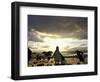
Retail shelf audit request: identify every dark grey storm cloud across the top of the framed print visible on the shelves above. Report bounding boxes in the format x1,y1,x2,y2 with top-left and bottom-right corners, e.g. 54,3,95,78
28,15,87,39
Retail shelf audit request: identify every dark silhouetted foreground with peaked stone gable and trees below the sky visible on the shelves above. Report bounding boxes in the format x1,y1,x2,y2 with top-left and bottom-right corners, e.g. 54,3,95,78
28,46,87,67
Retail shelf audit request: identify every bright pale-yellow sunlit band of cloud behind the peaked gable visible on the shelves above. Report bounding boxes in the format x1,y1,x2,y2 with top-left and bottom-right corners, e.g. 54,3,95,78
28,30,87,51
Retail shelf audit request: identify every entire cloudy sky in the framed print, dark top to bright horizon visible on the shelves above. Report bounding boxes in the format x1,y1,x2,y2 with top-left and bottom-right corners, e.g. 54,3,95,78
28,15,88,52
